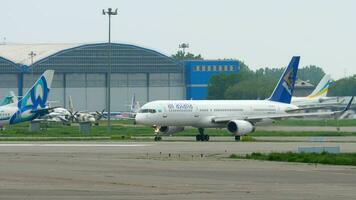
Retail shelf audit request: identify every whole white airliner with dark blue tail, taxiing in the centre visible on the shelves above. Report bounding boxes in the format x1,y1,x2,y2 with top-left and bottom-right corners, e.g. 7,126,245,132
135,56,353,141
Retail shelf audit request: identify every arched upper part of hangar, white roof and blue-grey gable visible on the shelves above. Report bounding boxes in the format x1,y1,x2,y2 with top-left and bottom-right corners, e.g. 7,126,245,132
0,43,183,73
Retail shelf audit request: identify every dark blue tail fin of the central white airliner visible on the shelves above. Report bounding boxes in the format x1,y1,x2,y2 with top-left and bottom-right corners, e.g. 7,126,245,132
269,56,300,104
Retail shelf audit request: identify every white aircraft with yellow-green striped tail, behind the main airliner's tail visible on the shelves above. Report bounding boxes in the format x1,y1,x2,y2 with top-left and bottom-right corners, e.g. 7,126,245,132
291,74,338,108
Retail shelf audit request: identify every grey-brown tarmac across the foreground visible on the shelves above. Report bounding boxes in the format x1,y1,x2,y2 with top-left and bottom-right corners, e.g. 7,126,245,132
0,141,356,200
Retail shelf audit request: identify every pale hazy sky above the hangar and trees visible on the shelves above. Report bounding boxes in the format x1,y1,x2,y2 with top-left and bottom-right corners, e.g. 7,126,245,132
0,0,356,79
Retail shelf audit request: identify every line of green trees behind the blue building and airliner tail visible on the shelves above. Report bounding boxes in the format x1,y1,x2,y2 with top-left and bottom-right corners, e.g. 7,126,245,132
172,50,356,99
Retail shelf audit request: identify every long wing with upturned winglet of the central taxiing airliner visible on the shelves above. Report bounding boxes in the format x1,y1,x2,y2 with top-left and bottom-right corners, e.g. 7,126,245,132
212,97,354,123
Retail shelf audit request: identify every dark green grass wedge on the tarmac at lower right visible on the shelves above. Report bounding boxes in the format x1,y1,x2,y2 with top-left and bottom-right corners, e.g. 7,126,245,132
230,152,356,166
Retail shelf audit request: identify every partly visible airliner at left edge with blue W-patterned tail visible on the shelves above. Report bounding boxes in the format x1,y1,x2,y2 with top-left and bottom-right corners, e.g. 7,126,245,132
0,70,54,126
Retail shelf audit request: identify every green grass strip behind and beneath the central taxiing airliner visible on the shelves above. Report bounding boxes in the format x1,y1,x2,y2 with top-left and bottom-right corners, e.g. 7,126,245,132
0,120,356,141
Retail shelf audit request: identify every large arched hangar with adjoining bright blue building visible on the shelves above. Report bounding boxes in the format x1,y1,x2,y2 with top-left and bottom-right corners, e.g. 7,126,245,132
0,43,239,111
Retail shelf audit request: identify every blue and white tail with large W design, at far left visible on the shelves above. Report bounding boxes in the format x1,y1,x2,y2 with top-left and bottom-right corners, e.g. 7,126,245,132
10,70,54,124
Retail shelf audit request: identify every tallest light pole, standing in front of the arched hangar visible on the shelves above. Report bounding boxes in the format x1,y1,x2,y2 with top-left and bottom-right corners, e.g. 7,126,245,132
103,8,117,132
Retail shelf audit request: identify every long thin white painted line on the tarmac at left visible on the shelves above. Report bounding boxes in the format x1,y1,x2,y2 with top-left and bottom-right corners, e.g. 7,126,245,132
0,143,152,147
